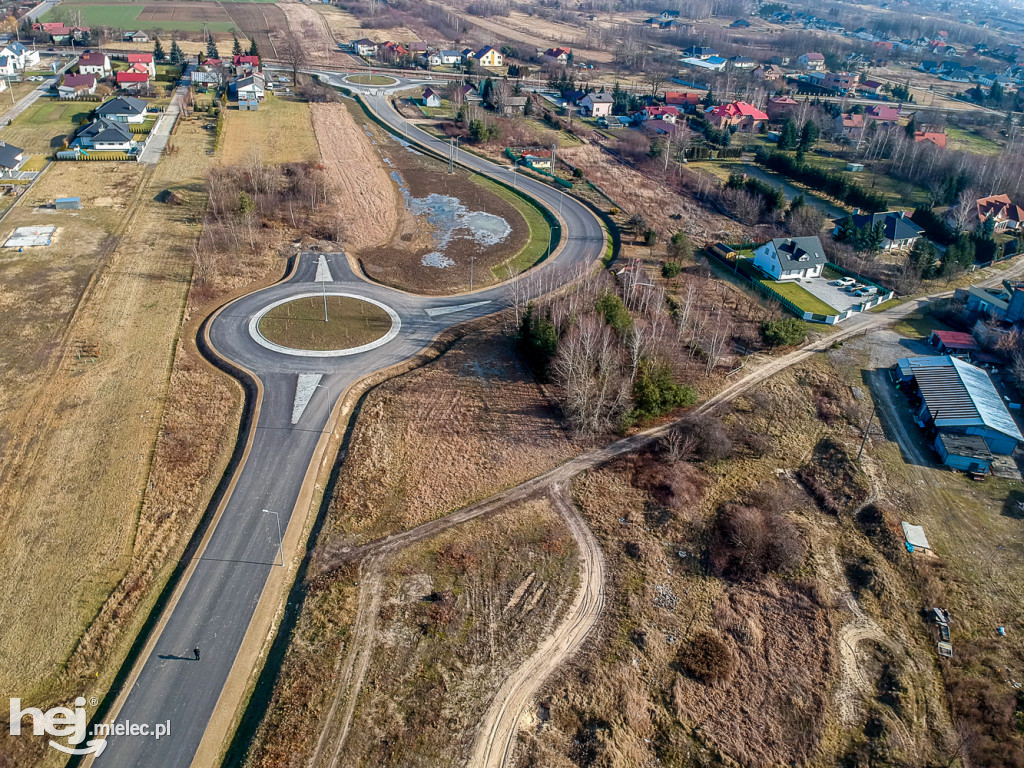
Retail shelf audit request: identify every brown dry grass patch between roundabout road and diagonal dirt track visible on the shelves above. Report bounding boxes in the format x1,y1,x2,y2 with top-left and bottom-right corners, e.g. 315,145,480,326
329,330,583,543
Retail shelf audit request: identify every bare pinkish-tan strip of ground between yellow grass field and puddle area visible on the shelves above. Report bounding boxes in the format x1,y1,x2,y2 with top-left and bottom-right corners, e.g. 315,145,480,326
309,100,398,250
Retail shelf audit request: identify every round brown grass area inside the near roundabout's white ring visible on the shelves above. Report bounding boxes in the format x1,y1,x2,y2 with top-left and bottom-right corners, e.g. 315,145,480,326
259,294,392,351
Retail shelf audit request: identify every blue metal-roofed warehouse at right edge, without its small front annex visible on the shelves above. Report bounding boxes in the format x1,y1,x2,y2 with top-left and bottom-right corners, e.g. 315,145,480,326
896,355,1024,455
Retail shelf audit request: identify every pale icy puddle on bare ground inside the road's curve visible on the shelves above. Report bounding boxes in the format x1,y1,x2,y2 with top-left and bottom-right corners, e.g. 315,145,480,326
391,171,512,269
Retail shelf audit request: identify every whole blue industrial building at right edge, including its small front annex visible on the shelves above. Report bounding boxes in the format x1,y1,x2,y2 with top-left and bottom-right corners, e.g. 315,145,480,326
893,355,1024,474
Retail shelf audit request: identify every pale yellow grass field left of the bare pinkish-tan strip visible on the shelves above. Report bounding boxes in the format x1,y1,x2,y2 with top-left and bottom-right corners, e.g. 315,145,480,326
220,94,319,165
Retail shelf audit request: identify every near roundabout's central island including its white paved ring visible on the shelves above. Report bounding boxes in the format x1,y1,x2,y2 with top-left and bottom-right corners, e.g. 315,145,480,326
249,291,401,357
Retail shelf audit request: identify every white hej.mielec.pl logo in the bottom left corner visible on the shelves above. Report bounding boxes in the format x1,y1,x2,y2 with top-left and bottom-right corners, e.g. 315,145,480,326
10,696,171,757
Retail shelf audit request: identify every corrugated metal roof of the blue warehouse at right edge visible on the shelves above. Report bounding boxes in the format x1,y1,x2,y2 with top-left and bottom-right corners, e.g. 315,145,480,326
899,355,1024,442
